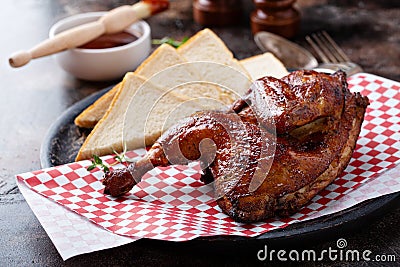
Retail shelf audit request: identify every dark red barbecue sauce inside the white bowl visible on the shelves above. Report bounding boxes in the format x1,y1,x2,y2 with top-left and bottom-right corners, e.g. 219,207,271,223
78,32,138,49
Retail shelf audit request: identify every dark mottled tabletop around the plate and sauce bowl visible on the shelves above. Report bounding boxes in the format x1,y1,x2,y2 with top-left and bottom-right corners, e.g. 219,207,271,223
0,0,400,266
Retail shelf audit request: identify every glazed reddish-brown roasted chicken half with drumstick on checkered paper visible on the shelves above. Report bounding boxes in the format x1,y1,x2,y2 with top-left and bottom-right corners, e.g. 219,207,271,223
103,71,369,222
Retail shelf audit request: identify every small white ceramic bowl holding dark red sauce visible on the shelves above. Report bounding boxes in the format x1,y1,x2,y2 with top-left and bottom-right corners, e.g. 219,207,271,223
49,12,151,81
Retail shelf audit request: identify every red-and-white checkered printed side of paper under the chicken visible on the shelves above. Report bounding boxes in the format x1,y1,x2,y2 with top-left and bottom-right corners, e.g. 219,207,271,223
17,73,400,247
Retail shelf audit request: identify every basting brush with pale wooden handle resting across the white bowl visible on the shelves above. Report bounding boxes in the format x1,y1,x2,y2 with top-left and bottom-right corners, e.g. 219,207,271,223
8,0,169,68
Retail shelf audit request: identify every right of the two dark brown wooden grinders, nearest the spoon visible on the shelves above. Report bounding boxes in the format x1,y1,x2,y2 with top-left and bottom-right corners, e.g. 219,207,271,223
250,0,300,38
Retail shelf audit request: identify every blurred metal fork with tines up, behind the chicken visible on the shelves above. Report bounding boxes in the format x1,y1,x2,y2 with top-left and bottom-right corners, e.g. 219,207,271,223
305,31,363,76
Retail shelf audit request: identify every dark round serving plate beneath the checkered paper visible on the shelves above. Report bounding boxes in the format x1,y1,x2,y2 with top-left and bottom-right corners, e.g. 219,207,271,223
40,87,400,243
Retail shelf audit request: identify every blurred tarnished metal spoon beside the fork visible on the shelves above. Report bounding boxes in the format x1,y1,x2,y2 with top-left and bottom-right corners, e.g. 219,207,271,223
254,32,318,69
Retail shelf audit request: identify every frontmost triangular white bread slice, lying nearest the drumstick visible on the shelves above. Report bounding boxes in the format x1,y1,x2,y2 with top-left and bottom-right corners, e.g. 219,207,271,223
76,73,199,161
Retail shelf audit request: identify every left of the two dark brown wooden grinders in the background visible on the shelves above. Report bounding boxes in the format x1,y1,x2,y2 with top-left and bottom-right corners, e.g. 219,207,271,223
193,0,242,26
